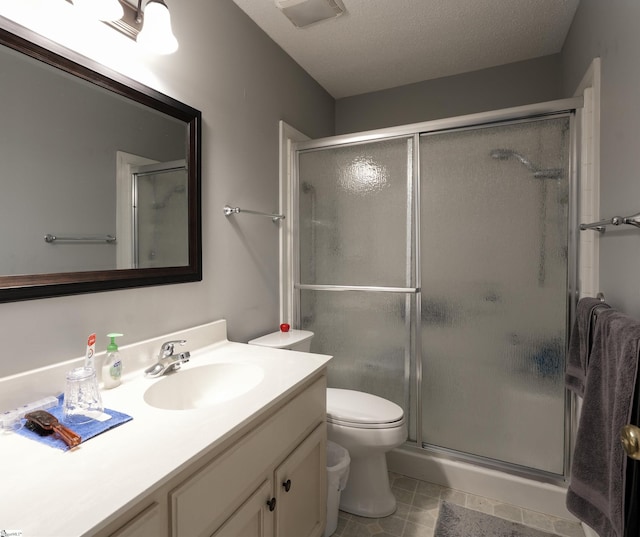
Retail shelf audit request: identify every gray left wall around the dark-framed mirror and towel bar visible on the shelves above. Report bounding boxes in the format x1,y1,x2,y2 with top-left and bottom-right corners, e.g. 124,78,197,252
0,0,334,377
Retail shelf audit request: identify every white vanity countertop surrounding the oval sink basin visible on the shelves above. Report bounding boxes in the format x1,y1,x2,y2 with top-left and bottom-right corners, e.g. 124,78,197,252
0,321,330,537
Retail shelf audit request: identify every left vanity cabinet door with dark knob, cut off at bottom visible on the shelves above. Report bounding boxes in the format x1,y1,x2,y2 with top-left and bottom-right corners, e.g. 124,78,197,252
211,481,273,537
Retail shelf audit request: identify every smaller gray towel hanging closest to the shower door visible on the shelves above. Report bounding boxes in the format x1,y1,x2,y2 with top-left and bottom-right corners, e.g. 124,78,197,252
564,297,610,397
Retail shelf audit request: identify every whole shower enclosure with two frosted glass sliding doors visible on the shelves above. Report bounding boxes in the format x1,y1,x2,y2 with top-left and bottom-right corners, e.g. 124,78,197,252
290,99,575,516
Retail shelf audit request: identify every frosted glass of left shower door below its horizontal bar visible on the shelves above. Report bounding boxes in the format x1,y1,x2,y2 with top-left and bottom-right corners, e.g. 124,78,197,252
300,290,410,412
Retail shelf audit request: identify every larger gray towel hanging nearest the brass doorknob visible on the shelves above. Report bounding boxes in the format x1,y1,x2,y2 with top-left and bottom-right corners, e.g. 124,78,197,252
567,309,640,537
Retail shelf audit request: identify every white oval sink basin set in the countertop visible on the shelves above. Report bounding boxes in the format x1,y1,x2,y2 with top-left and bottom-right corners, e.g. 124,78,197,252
144,363,264,410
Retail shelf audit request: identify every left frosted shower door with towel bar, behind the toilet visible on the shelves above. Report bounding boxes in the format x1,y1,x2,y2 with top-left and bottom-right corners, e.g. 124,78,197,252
296,136,416,411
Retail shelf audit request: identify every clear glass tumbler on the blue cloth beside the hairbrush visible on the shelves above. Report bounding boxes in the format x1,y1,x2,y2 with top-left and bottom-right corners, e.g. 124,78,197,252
62,367,104,425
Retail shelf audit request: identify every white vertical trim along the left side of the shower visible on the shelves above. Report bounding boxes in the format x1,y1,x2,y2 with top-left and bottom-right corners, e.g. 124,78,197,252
278,120,310,324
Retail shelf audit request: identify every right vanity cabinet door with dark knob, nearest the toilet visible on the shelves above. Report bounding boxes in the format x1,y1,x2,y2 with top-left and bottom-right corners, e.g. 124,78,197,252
275,423,327,537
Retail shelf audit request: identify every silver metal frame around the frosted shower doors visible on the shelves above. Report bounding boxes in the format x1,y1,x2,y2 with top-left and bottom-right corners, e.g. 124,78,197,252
290,96,583,483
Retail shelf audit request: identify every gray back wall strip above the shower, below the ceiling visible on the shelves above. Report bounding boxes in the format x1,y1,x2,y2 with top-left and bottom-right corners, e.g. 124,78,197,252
336,54,562,134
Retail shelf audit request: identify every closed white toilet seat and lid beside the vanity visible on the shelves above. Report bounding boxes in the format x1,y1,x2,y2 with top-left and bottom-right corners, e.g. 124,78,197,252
327,388,405,429
